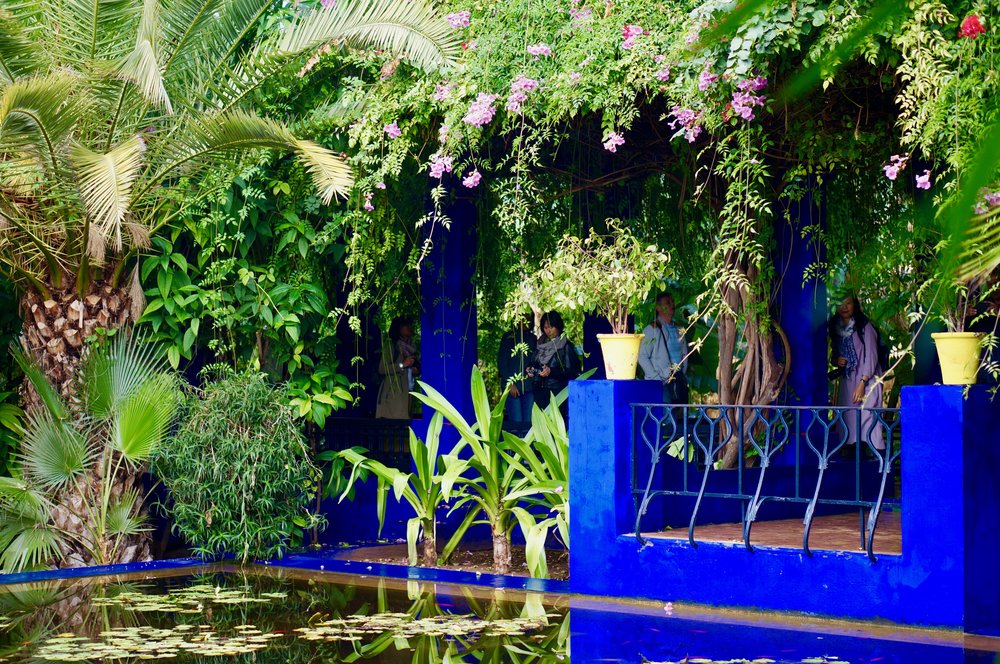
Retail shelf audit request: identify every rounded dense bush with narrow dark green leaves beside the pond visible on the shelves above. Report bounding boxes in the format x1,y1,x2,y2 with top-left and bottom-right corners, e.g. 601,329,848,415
155,368,321,561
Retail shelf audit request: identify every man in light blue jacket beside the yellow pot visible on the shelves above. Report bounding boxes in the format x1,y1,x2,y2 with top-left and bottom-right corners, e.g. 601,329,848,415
639,293,689,404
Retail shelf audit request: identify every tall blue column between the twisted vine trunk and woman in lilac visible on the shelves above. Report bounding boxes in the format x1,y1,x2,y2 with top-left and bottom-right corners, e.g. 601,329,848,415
774,178,829,406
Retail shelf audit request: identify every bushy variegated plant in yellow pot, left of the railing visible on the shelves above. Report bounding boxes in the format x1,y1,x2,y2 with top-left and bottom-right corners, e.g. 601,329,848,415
513,219,670,380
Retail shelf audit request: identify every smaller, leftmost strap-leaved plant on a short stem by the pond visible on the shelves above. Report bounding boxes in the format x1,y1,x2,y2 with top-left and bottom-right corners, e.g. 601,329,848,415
324,413,469,566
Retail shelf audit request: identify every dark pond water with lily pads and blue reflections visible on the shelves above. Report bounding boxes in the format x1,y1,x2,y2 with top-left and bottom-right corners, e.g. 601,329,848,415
0,567,1000,664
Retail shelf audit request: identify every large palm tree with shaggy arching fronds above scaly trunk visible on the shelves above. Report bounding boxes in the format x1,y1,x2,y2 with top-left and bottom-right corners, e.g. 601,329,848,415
0,0,458,395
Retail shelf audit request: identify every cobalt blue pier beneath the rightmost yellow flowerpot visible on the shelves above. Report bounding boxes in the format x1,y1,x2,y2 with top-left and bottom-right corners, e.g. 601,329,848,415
901,385,1000,636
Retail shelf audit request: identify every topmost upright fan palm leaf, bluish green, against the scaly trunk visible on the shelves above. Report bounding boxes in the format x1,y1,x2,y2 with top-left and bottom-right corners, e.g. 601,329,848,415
79,334,166,422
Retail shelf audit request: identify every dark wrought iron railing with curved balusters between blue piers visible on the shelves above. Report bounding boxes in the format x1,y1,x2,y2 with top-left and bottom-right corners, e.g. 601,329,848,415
632,404,900,562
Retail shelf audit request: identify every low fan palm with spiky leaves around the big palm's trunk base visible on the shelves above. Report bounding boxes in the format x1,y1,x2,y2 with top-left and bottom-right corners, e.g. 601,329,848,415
0,334,180,572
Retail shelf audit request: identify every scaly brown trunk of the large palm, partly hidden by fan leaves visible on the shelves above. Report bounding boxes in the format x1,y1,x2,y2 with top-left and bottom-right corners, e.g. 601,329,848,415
21,282,150,567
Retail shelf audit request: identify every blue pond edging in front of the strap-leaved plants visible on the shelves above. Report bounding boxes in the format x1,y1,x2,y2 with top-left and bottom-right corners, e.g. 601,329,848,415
259,549,570,593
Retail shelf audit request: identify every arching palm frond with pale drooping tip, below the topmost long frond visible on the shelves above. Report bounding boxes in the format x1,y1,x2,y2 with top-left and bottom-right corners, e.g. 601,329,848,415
143,111,353,203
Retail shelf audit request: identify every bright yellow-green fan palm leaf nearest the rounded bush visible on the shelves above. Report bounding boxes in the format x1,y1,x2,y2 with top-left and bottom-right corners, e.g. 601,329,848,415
111,373,180,463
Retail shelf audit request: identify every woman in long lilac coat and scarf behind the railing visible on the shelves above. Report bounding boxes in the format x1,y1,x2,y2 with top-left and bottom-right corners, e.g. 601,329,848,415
828,295,885,450
